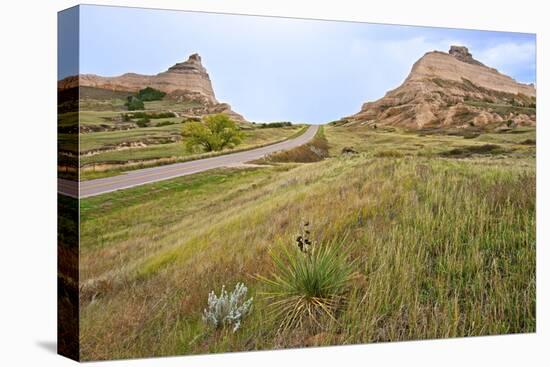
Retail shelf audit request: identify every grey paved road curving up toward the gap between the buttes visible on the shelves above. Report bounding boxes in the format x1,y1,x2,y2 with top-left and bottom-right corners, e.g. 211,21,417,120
57,125,319,198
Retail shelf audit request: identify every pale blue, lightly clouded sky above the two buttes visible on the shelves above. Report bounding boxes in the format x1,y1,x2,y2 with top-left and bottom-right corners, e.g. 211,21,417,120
58,5,536,123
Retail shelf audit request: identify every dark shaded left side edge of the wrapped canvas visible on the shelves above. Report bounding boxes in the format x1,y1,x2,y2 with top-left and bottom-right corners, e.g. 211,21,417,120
57,7,80,360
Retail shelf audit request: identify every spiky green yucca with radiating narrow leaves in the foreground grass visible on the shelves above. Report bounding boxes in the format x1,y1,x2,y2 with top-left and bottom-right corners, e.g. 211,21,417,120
259,241,353,331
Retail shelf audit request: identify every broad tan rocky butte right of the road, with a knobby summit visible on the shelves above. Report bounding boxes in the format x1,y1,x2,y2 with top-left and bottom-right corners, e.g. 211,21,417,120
348,46,536,129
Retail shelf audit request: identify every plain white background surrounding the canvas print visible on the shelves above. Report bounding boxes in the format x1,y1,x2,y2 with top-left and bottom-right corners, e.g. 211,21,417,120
0,0,550,367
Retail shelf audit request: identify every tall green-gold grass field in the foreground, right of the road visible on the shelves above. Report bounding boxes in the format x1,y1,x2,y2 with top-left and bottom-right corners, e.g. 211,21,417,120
80,127,535,360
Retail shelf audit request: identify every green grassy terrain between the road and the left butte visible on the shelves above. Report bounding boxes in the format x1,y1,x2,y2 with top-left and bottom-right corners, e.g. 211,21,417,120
66,92,305,180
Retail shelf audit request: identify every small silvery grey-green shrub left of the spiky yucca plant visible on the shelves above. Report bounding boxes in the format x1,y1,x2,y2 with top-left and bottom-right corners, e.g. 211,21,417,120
202,283,252,332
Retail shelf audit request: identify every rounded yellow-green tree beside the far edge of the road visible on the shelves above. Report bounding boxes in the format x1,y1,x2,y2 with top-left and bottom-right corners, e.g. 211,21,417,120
183,113,243,152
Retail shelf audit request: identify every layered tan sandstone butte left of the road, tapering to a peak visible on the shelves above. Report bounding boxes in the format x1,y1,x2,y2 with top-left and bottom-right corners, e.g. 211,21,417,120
58,53,244,121
